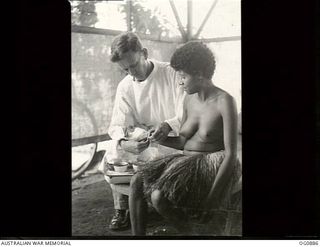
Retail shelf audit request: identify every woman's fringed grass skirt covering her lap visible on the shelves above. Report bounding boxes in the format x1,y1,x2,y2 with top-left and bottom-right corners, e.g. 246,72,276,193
139,151,241,210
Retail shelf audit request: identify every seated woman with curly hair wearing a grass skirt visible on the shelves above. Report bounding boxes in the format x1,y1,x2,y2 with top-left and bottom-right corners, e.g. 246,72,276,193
129,41,239,235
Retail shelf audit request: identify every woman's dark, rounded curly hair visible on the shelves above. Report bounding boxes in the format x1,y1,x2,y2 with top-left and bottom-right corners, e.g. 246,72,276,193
170,41,216,80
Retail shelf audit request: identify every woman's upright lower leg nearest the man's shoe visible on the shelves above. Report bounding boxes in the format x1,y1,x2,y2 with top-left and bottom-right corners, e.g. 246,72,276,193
129,173,148,236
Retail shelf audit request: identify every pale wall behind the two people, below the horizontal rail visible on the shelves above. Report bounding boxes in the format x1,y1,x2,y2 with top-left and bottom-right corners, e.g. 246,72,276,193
71,33,241,139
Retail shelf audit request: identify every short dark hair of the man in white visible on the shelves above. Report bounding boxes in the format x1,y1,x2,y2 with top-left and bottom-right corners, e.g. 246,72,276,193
110,32,143,62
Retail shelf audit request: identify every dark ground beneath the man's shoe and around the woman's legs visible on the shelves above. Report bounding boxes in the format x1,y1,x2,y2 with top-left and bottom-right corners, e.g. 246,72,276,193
72,173,242,236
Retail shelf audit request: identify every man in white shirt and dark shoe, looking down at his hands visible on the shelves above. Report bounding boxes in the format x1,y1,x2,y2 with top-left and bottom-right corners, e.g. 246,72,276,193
108,32,185,230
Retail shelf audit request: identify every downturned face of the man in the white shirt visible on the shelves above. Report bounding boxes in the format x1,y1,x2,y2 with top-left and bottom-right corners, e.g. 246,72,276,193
117,51,147,81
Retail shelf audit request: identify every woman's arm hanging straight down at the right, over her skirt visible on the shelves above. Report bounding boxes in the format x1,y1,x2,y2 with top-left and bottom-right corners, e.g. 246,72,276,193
207,95,238,207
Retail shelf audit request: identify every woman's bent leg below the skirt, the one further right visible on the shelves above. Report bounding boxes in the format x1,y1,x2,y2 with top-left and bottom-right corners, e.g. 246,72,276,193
151,190,190,234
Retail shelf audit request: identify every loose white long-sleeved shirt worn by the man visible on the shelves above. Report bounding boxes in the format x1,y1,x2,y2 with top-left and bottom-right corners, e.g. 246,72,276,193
108,60,185,140
